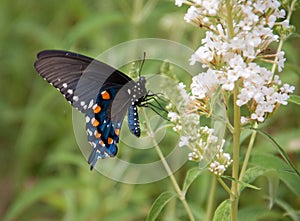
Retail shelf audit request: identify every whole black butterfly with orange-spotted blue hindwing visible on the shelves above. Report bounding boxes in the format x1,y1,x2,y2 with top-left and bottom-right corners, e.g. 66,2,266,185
34,50,162,170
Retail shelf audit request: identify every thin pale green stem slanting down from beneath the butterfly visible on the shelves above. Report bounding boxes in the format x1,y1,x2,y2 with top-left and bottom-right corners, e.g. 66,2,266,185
142,109,195,221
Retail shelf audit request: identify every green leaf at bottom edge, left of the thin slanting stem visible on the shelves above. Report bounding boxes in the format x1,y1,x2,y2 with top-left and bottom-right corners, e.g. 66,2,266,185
146,191,176,221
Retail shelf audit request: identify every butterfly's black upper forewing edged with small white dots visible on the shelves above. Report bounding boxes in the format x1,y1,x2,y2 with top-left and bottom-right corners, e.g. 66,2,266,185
34,50,131,113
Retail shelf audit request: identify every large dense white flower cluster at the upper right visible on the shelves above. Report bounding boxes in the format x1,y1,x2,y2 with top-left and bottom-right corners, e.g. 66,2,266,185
175,0,295,123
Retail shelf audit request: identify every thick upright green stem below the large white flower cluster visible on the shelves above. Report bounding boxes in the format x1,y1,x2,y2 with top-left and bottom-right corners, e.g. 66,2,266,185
230,81,241,221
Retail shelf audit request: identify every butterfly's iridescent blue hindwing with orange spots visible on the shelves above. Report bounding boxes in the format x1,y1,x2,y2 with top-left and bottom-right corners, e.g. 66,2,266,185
86,76,132,169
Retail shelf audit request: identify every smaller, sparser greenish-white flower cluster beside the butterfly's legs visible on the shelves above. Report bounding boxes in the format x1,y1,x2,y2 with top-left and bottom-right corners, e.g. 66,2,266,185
164,80,232,175
